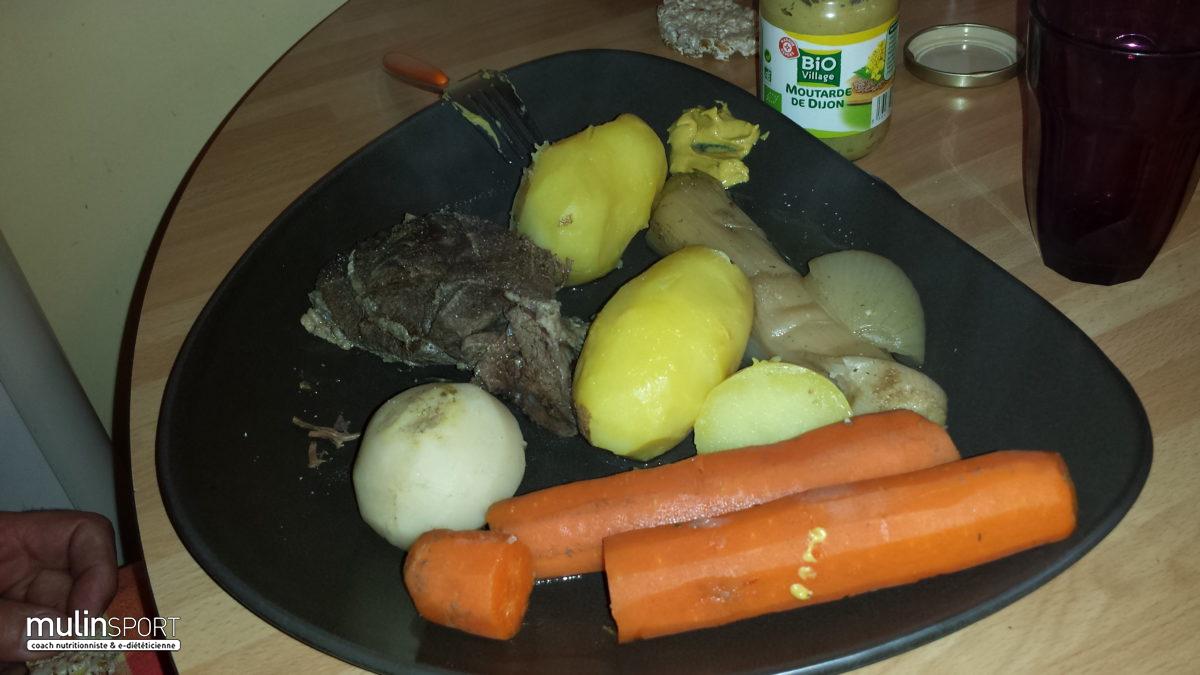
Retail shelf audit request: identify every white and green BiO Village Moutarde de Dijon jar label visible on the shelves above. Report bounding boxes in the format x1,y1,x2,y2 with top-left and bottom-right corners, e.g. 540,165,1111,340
761,17,900,138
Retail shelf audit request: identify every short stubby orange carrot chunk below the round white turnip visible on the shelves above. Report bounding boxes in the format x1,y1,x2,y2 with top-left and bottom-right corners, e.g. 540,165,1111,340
404,530,534,640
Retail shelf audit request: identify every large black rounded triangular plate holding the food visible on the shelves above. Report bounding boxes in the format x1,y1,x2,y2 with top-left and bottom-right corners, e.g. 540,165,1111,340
157,50,1151,674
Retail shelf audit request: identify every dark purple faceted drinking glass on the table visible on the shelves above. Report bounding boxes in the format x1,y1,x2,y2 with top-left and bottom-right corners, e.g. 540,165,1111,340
1024,0,1200,285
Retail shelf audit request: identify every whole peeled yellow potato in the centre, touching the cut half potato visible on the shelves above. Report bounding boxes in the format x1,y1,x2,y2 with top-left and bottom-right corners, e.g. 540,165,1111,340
572,246,754,460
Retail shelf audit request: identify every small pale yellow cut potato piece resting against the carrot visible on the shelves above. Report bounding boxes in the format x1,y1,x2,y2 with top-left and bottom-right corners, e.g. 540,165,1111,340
696,360,851,453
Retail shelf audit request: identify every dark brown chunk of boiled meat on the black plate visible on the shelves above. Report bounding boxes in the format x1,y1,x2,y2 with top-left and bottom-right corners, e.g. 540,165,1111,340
300,213,587,436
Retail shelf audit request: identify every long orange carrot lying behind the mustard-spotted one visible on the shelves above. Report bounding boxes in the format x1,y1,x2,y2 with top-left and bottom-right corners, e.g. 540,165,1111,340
487,411,959,579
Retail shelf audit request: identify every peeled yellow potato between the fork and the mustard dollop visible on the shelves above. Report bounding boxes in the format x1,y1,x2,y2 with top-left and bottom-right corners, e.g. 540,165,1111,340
512,114,667,286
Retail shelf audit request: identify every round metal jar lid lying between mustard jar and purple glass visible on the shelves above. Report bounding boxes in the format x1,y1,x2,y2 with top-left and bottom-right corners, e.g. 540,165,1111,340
904,24,1025,88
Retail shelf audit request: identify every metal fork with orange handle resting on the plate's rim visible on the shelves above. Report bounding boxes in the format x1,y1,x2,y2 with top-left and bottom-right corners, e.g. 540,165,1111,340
383,52,544,166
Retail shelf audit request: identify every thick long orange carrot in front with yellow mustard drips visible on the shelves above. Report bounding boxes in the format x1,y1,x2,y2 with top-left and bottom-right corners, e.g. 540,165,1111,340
604,450,1075,643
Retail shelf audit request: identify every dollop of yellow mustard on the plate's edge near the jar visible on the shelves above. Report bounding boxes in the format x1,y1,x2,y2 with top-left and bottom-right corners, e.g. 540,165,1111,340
667,101,758,187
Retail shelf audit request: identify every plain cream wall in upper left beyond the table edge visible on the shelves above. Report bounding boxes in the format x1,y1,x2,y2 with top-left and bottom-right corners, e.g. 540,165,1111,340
0,0,343,432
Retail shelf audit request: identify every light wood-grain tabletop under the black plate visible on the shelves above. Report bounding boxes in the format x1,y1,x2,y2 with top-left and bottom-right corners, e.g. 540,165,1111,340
130,0,1200,673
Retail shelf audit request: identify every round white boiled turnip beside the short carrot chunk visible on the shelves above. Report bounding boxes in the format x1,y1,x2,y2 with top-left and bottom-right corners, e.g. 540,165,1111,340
353,383,524,549
